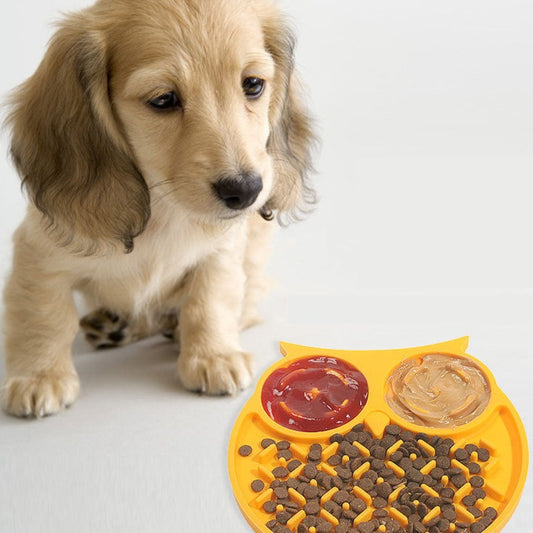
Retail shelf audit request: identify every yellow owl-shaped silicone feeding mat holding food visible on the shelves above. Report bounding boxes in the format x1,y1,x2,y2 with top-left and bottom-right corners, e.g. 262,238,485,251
228,337,528,533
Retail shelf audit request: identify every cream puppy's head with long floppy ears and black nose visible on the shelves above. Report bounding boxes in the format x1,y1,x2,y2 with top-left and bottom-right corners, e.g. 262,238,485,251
10,0,312,250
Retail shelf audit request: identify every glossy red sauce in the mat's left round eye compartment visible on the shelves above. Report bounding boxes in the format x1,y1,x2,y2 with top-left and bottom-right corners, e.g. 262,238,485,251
261,356,368,431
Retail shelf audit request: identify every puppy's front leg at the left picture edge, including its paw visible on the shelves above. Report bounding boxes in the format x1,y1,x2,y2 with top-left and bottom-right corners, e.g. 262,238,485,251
2,237,79,417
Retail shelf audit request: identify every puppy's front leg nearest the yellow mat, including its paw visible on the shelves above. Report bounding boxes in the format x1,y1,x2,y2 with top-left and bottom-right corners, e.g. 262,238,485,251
178,235,253,394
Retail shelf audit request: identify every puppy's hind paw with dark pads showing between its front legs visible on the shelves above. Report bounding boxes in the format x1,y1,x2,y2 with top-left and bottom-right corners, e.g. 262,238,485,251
80,309,133,348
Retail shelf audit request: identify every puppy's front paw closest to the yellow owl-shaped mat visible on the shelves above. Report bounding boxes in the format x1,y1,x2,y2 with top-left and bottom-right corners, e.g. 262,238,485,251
178,351,253,395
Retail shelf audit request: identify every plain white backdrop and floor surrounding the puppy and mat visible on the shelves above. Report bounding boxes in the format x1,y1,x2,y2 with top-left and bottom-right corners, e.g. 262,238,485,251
0,0,533,533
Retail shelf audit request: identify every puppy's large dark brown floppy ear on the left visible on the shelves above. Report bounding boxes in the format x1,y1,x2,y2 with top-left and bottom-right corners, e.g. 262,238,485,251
8,15,150,253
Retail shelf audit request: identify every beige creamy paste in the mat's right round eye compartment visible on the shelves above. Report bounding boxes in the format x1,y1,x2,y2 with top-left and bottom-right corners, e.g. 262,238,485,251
387,354,490,428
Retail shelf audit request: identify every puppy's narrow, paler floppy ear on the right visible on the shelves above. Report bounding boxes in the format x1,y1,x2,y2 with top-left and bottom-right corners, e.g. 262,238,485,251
263,12,316,217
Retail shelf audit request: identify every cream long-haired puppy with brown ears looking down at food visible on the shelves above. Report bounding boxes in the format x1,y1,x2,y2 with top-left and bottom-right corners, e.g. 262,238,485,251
2,0,314,417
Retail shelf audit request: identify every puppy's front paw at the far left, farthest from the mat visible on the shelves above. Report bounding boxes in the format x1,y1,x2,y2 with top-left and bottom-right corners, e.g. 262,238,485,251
2,373,80,418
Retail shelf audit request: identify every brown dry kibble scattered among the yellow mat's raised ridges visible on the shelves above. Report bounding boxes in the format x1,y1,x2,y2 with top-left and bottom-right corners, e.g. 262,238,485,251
241,424,498,533
